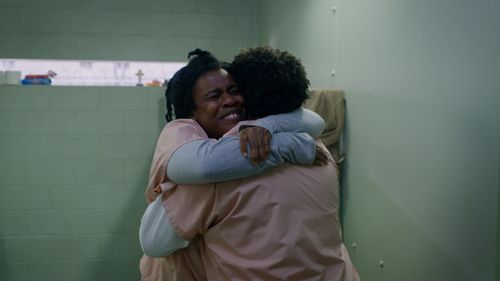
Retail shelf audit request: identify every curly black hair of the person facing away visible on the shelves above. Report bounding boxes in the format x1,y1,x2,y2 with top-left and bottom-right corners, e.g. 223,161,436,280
229,47,309,119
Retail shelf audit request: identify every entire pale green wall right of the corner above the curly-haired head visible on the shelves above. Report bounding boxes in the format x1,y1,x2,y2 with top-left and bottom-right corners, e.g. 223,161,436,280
259,0,500,281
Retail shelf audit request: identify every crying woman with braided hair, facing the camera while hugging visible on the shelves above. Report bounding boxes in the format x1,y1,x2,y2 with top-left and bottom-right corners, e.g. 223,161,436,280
140,50,326,280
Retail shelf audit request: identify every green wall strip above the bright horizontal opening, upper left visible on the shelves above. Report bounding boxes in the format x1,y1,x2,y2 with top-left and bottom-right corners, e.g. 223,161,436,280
0,0,257,61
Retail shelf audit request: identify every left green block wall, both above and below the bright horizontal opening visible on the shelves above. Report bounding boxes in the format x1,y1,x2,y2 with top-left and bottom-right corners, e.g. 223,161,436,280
0,0,258,281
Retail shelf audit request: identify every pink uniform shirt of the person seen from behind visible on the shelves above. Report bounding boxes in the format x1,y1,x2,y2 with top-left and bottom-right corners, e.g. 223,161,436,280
162,122,359,281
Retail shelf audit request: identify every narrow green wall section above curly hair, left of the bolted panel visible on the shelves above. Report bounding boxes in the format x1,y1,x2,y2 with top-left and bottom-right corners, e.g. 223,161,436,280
258,0,338,87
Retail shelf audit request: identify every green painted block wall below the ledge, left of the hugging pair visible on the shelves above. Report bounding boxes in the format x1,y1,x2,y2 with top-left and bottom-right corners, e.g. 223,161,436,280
0,86,164,281
